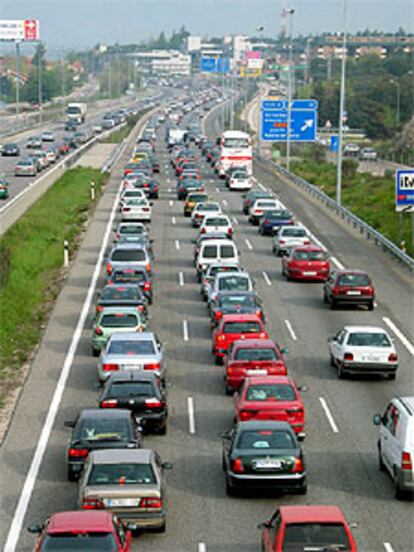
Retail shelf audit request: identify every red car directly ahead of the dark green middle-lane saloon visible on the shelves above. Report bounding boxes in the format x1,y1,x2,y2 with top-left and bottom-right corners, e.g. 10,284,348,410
233,376,305,438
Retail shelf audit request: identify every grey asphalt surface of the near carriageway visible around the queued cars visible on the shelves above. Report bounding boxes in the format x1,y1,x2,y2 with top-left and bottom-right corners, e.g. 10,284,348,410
0,92,414,552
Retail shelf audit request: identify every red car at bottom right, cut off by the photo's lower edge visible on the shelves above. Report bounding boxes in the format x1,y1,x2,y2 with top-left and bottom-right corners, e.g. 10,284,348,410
258,506,357,552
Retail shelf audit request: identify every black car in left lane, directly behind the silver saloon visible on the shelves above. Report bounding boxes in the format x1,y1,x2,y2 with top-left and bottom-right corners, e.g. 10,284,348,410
99,370,168,435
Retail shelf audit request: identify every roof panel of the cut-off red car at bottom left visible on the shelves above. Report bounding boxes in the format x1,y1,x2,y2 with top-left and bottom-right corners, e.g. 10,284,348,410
47,510,113,534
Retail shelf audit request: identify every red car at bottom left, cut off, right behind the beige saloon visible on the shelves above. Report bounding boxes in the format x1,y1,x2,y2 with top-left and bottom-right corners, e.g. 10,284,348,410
28,510,132,552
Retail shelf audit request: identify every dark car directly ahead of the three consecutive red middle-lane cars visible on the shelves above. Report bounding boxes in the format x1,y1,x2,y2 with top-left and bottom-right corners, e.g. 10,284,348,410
210,291,266,326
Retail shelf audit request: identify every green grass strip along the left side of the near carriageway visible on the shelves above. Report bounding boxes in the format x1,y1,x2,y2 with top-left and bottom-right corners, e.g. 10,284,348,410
0,168,108,407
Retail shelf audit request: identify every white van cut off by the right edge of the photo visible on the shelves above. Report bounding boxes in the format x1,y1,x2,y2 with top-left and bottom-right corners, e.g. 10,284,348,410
374,397,414,499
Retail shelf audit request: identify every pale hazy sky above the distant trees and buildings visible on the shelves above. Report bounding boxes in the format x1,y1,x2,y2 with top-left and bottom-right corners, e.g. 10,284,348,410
0,0,414,51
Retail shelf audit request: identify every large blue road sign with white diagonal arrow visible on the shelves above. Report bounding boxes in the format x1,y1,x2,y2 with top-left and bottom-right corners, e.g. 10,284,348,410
261,100,318,142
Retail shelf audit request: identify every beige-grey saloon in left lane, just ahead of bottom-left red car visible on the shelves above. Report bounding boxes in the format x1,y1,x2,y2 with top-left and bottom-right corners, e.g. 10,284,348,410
78,449,172,532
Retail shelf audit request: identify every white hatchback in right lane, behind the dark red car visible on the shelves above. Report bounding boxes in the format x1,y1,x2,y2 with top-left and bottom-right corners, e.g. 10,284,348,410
328,326,398,380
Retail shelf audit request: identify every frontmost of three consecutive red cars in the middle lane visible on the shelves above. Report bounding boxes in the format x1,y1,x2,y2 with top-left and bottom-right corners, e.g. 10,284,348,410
211,314,269,364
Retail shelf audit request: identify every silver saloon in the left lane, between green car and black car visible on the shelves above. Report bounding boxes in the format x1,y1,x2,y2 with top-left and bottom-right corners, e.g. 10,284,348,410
98,332,166,381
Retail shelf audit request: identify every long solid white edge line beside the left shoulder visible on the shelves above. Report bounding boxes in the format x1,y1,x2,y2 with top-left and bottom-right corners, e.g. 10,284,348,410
3,176,121,552
